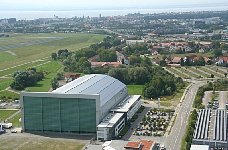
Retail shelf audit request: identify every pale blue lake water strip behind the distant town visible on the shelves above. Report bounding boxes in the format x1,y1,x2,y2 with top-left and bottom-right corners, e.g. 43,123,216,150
0,6,228,20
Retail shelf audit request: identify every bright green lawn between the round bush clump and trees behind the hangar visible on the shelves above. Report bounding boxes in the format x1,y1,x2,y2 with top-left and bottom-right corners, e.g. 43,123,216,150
26,61,62,92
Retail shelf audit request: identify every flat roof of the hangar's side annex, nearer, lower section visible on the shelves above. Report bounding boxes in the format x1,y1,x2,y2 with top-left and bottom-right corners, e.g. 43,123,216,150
97,113,124,128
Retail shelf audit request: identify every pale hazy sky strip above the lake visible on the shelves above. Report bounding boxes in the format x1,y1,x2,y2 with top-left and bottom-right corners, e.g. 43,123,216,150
0,0,228,11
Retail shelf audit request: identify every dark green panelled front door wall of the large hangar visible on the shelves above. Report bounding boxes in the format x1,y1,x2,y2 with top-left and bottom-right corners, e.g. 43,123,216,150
23,96,96,133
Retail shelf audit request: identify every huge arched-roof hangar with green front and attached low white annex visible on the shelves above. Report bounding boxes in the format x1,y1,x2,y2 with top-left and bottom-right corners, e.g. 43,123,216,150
20,74,141,140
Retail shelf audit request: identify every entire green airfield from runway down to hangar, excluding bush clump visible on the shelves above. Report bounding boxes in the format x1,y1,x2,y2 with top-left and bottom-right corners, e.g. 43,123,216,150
0,33,104,96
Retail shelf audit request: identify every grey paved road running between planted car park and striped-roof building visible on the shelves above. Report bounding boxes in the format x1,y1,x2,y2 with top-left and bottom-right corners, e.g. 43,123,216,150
165,82,205,150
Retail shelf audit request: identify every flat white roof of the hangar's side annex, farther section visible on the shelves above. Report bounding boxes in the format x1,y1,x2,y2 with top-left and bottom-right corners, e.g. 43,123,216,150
111,95,141,112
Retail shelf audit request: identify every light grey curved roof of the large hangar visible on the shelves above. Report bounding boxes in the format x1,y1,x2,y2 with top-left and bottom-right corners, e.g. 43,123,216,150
53,74,126,106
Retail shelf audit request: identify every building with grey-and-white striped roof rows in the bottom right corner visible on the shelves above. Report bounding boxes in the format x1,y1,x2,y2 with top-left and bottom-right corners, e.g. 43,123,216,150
192,109,228,148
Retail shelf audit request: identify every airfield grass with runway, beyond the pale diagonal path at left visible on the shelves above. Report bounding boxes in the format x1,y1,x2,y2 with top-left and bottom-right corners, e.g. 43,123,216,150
0,33,104,70
